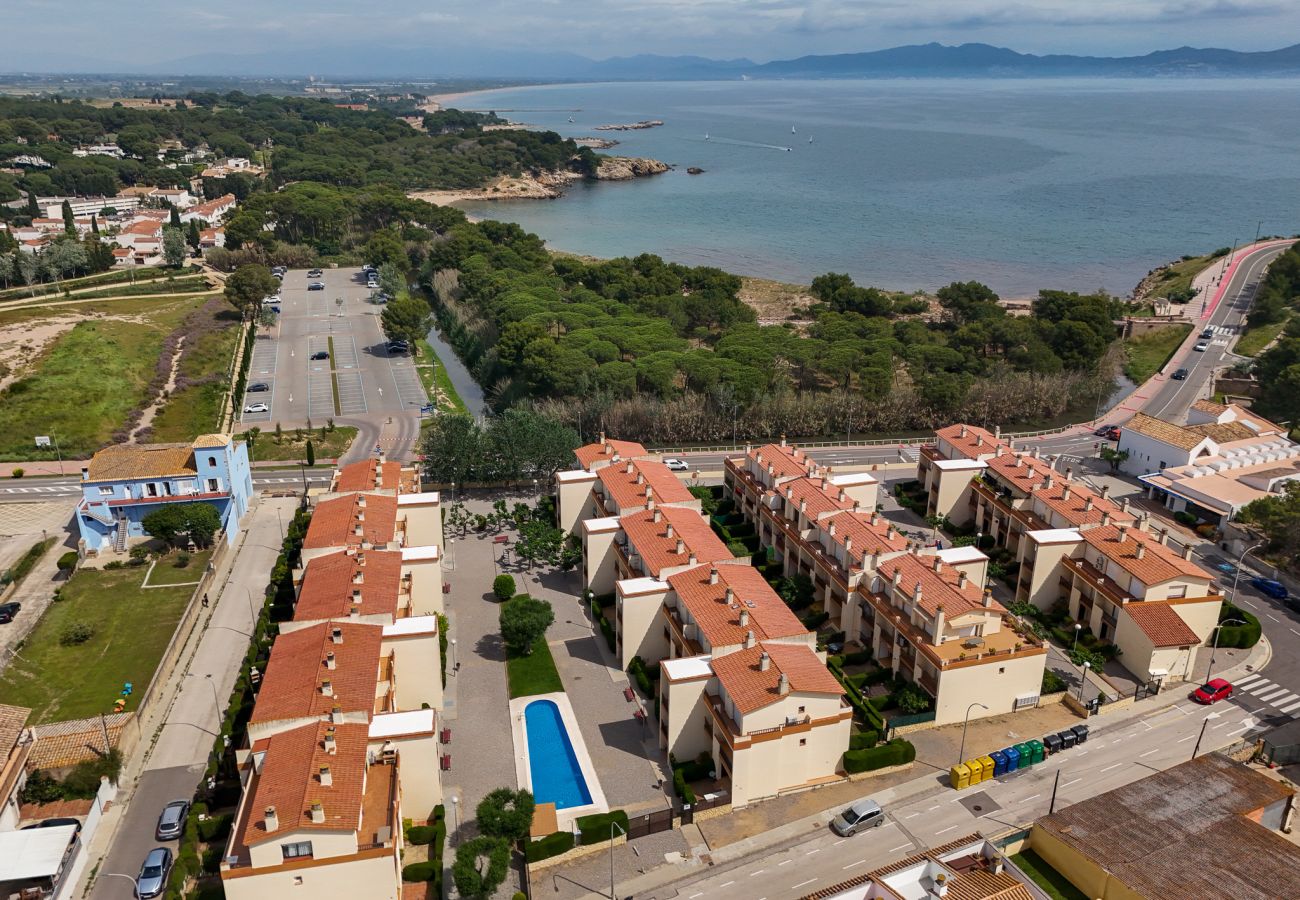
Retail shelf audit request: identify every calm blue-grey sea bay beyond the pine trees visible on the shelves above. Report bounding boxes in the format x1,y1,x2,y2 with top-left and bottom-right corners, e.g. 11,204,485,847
460,79,1300,295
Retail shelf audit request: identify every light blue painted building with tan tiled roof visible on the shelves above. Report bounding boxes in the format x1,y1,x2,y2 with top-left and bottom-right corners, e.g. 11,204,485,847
77,434,252,553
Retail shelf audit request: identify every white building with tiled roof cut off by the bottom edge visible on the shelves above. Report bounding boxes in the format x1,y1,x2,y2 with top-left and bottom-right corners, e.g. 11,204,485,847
803,834,1048,900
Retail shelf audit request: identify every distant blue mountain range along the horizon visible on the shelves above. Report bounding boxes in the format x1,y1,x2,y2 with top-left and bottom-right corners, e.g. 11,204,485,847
32,42,1300,81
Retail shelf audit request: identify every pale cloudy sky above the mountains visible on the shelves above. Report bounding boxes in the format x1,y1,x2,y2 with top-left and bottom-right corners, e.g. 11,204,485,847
0,0,1300,74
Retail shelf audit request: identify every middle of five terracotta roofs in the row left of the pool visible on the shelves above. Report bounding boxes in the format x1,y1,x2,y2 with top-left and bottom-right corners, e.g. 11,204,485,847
294,550,402,622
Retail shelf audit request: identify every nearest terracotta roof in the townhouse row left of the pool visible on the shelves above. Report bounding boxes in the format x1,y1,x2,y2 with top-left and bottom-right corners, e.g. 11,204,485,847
244,722,369,844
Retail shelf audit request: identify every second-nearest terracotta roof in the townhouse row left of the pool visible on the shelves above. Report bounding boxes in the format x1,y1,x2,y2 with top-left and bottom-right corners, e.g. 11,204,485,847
251,622,384,723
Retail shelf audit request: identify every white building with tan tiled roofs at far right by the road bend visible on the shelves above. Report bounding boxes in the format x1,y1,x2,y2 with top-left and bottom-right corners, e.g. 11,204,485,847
1119,401,1300,528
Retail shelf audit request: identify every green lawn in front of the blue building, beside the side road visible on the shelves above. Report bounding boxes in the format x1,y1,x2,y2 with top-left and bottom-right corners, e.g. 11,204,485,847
0,567,194,723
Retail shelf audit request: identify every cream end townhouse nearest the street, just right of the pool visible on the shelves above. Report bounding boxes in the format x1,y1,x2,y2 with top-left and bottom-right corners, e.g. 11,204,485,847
659,635,853,808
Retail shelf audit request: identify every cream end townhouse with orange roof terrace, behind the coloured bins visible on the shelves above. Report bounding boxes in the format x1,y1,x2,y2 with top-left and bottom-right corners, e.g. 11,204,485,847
858,548,1047,726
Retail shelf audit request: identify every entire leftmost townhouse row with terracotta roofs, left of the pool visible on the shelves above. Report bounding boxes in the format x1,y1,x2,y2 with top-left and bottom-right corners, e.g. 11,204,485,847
221,458,443,900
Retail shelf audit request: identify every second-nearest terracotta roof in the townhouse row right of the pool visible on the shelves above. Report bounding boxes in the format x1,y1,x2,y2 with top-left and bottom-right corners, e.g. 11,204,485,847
668,566,807,646
